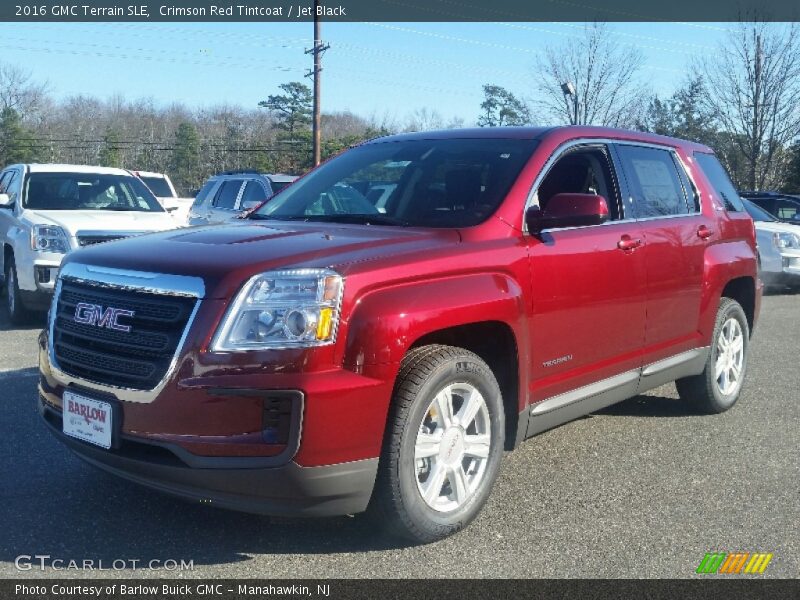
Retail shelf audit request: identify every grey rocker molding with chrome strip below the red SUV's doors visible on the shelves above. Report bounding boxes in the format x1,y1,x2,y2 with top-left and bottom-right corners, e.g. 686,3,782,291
526,347,710,437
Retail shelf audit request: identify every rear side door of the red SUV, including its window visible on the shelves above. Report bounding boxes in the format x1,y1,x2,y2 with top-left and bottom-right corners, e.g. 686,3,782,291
616,142,708,367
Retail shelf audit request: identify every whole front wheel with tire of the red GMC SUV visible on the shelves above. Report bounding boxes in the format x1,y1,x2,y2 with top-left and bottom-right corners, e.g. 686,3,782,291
370,345,505,543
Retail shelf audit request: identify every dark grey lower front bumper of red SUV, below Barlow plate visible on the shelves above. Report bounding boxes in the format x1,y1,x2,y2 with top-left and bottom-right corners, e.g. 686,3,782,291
39,397,378,517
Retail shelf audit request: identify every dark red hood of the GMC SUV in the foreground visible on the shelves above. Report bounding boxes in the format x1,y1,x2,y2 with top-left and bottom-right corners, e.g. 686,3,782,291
66,221,461,298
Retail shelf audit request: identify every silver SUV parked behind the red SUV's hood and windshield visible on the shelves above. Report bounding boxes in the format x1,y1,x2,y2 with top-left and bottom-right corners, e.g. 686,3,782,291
188,171,297,225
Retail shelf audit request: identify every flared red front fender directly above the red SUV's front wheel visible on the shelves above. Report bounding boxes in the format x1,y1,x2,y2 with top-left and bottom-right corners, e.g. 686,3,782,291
344,273,528,370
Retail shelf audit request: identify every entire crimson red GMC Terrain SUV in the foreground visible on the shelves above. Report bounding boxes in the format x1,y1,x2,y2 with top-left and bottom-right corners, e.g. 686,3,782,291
39,127,762,542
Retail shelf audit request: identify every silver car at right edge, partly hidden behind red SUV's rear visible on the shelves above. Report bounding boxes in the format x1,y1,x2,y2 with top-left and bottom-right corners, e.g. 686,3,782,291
744,199,800,291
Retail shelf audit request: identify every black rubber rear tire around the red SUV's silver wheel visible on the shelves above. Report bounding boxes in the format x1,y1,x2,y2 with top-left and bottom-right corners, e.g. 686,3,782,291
675,297,750,414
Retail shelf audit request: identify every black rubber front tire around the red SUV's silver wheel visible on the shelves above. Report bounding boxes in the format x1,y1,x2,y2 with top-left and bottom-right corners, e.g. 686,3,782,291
369,345,505,543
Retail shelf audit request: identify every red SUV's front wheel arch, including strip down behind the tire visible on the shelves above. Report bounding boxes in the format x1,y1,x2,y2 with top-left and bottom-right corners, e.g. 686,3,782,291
342,273,529,449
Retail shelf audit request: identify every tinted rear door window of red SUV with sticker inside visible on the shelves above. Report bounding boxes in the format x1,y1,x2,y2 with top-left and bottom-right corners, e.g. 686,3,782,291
618,144,690,219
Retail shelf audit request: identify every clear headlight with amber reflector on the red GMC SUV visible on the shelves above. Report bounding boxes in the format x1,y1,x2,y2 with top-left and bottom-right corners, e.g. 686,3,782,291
211,269,343,352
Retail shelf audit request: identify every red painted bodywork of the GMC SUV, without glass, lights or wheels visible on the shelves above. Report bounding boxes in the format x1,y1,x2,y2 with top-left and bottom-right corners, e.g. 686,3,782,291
42,127,760,466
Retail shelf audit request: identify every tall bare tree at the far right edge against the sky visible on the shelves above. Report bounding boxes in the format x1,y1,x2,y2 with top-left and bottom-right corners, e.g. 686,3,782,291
697,21,800,190
